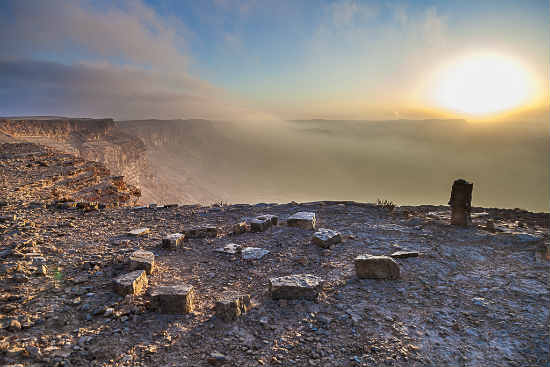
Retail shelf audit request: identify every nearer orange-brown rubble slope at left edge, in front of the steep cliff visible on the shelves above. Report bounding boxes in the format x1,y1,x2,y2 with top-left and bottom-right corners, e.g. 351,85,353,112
0,143,141,207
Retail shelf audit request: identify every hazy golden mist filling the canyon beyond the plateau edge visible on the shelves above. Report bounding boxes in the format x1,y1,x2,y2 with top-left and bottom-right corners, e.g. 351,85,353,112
120,120,549,211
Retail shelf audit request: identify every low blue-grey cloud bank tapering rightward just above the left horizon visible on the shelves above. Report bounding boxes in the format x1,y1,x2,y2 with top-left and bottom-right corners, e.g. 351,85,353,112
0,60,269,120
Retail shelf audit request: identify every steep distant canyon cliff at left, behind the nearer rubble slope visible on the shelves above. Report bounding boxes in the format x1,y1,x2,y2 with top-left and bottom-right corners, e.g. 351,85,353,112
0,118,154,202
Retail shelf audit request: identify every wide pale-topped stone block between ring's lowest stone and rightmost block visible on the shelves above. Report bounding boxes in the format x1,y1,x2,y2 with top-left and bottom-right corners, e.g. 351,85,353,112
269,274,322,301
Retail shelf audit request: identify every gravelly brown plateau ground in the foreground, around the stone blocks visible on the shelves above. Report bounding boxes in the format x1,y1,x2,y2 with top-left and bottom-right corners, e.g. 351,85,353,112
0,142,550,367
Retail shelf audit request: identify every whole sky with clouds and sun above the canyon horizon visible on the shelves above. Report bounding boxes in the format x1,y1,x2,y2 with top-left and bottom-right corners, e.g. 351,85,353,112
0,0,550,121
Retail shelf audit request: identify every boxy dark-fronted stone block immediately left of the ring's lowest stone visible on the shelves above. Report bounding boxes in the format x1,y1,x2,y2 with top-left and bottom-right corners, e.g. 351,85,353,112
151,284,195,314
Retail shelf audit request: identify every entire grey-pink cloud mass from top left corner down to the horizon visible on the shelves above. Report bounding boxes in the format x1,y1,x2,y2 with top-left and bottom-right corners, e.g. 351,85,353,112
0,0,272,119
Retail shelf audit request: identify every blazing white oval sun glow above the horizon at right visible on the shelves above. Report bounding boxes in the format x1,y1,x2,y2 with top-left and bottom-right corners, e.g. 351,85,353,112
433,54,531,115
